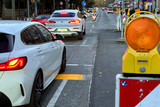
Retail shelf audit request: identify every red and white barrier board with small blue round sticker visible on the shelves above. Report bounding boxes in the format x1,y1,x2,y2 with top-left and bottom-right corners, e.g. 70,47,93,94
115,74,160,107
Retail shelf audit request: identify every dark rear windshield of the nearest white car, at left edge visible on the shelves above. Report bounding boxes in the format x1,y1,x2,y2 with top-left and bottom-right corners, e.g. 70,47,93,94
0,33,14,53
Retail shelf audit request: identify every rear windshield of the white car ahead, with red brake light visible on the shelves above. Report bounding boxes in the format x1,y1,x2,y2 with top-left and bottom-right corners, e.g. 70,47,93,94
52,12,75,17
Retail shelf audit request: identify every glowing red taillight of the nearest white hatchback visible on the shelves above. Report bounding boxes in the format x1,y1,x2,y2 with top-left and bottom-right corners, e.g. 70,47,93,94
0,57,27,71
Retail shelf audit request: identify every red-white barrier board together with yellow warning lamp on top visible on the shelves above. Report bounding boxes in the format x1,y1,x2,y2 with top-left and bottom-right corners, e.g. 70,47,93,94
115,11,160,107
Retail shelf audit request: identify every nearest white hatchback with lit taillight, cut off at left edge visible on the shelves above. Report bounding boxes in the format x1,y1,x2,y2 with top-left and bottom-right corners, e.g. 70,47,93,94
0,20,66,107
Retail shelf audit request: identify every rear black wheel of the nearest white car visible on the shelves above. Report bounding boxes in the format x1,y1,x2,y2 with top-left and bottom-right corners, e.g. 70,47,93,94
29,72,43,107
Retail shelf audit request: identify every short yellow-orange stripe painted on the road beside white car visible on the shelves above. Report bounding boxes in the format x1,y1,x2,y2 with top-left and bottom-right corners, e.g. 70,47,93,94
55,74,83,80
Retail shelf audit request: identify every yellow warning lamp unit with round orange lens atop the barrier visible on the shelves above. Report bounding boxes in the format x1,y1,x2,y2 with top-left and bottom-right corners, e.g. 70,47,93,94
122,11,160,76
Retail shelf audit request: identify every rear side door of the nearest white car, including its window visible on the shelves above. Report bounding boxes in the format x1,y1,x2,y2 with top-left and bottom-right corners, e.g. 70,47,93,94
21,25,47,77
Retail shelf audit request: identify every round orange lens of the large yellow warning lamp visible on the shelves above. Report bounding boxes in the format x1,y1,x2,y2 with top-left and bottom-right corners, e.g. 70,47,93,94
125,17,160,52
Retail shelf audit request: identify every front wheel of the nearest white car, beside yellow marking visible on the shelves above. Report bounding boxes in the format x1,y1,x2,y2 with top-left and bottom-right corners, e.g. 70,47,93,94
60,47,66,73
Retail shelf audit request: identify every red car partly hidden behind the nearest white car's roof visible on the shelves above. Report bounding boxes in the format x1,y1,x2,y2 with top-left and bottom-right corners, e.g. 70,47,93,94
31,14,51,25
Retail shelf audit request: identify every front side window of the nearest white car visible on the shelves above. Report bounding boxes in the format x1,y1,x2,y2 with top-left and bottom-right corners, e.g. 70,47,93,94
37,25,53,41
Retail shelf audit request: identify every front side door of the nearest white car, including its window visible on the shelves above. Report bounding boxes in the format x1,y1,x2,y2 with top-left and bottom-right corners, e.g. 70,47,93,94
37,25,62,82
